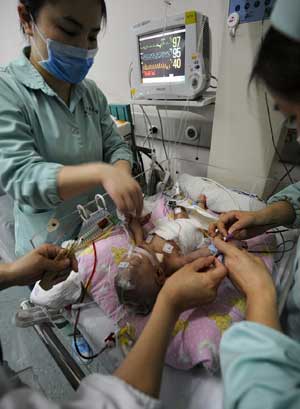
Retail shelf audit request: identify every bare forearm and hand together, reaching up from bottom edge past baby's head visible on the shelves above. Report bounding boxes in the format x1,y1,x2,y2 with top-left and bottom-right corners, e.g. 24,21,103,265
115,253,227,396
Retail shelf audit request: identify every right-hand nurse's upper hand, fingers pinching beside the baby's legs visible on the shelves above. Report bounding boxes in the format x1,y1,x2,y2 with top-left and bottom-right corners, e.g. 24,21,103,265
208,210,266,240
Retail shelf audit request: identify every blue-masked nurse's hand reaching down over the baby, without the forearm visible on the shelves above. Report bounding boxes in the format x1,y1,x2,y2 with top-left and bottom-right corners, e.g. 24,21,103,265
100,161,144,217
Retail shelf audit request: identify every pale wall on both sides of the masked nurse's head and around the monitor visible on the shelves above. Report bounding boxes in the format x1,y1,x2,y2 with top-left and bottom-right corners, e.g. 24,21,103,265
0,0,225,99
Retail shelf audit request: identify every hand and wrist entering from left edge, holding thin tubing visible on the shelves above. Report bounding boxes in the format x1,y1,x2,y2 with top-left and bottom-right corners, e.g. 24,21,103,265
1,244,78,287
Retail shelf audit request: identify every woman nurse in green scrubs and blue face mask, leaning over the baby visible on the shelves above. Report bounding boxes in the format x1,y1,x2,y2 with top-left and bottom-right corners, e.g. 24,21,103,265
0,0,143,255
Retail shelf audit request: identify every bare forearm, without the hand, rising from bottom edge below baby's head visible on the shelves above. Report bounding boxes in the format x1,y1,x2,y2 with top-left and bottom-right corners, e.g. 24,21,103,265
115,295,178,398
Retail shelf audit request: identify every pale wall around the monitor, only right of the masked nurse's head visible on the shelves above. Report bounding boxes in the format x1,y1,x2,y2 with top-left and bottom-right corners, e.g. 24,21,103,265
91,0,225,102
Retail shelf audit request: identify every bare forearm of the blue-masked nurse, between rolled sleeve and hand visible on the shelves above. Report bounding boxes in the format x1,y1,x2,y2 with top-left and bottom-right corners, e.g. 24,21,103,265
57,163,110,200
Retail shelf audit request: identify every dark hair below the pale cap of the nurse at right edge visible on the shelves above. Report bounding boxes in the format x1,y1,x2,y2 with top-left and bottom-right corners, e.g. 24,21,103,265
249,27,300,103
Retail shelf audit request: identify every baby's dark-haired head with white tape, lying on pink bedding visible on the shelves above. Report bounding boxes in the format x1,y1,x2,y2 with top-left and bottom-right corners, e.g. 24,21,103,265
115,247,165,315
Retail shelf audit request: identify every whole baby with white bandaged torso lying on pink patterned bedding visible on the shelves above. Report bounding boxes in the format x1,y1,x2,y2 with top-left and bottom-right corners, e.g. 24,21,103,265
115,195,221,315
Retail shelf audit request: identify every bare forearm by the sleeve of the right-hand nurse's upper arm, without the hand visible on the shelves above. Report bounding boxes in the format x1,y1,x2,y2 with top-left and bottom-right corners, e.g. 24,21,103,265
258,201,296,227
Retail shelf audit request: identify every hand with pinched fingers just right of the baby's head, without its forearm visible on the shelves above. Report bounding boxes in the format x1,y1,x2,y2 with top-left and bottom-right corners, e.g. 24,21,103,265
159,257,227,313
